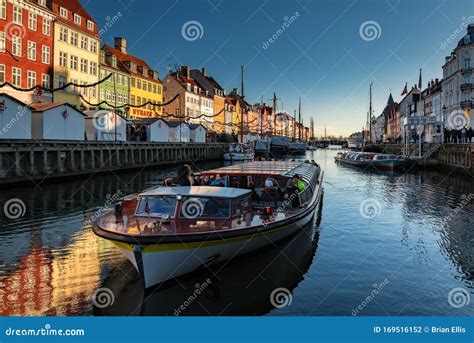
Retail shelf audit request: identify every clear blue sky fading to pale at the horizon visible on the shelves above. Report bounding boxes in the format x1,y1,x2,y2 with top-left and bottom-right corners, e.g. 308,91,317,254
82,0,474,135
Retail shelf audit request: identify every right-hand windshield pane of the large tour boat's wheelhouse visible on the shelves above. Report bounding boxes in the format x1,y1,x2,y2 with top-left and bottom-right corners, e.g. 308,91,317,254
179,197,230,219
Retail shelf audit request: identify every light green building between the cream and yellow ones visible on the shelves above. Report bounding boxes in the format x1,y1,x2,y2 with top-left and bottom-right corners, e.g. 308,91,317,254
99,46,131,115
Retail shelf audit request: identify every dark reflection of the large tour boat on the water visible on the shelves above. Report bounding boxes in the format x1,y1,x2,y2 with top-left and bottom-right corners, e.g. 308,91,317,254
94,210,320,316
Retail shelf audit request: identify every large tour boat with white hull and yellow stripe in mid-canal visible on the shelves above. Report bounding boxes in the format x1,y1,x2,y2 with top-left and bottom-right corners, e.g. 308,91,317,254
93,161,323,288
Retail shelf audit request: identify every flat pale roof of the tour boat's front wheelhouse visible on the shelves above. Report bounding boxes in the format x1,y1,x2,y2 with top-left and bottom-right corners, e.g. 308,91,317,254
140,186,251,198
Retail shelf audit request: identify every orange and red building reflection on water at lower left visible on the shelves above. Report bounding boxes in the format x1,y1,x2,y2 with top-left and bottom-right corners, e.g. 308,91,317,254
0,230,104,316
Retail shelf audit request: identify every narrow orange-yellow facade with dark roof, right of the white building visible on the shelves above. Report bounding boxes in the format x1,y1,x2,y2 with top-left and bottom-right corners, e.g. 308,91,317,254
190,68,226,133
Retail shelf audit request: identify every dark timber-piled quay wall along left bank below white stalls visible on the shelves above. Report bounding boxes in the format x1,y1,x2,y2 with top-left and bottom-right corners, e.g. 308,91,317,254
0,140,228,185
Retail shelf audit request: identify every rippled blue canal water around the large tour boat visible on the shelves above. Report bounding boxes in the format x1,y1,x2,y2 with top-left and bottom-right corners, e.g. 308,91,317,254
0,150,474,316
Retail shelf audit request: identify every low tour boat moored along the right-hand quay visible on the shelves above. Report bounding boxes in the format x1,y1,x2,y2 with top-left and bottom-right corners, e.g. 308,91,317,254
335,152,408,171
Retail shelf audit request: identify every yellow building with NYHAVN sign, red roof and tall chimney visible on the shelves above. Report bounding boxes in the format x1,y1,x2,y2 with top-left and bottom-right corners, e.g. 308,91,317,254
108,37,163,118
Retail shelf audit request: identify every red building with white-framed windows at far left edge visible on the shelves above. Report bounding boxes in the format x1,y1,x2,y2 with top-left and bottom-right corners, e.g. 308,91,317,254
0,0,55,103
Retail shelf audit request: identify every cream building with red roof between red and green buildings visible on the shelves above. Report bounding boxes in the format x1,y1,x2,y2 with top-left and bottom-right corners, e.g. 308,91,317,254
51,0,100,110
